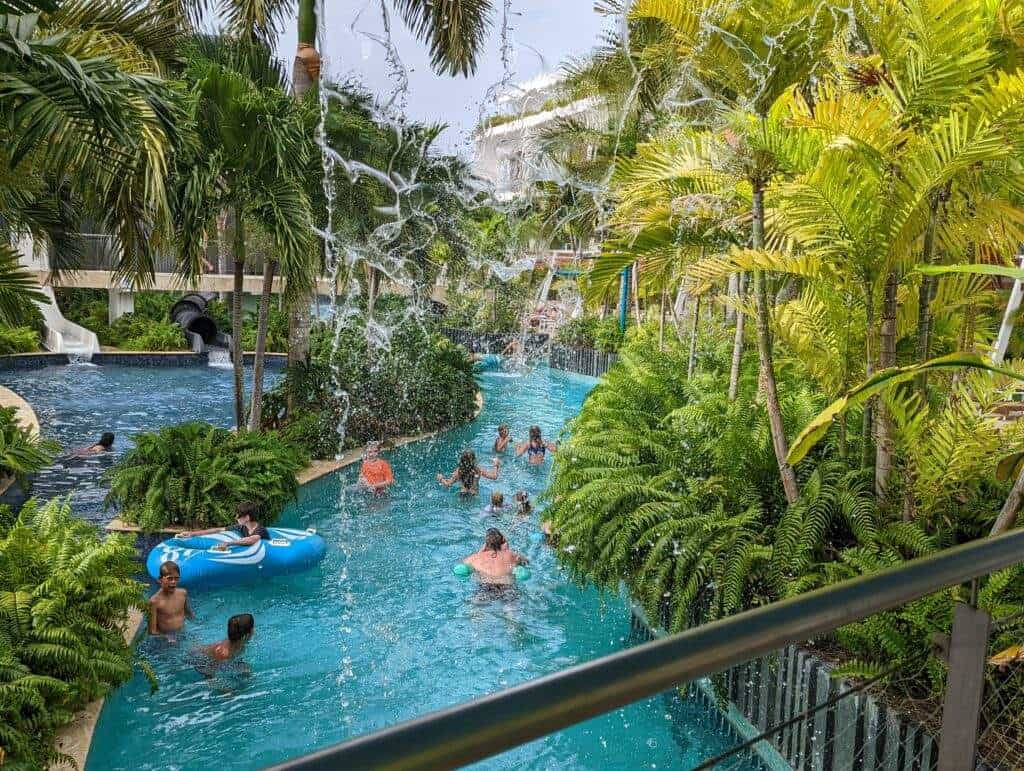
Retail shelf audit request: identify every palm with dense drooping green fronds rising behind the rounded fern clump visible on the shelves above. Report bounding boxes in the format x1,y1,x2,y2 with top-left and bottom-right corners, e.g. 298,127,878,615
178,40,312,428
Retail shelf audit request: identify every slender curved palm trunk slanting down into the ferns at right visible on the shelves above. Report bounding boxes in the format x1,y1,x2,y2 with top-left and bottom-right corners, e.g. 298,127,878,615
753,179,800,504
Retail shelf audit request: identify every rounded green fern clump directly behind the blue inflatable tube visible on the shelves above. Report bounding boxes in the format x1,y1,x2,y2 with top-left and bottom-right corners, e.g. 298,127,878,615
105,422,307,530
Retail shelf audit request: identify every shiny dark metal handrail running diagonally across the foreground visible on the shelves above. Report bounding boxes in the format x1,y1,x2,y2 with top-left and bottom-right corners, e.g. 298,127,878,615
271,529,1024,771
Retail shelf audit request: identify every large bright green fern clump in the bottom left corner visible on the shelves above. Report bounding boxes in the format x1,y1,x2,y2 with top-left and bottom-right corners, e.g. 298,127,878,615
0,501,144,769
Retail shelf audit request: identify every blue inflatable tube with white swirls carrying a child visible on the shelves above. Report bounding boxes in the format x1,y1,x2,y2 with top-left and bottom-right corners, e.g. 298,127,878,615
145,527,327,589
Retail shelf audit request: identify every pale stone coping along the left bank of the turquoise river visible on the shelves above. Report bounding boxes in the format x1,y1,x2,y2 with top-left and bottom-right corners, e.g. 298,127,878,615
55,390,483,771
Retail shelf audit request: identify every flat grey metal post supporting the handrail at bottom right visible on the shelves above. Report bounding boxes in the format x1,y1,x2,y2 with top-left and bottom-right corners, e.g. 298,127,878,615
939,603,992,771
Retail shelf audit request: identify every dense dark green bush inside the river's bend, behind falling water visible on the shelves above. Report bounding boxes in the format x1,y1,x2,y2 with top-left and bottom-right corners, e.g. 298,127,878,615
263,298,477,458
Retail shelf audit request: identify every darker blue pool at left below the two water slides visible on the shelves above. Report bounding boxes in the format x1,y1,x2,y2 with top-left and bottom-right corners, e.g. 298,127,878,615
0,363,281,524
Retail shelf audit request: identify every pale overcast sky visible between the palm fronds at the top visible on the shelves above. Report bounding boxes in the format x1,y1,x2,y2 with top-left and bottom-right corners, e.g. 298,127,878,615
279,0,609,156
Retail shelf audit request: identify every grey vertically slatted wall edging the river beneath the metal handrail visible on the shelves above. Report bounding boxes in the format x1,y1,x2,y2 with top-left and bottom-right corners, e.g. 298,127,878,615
631,603,939,771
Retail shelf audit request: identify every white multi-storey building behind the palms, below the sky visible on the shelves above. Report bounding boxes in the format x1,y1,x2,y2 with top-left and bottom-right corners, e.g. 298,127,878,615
473,74,606,200
